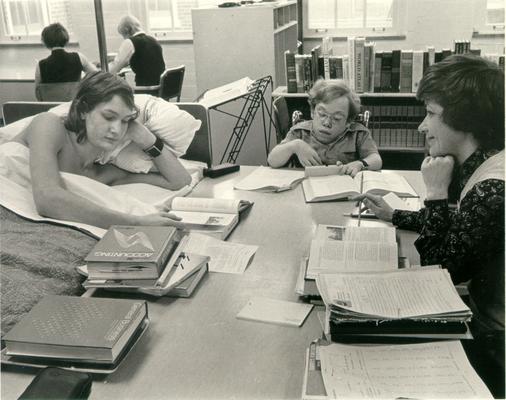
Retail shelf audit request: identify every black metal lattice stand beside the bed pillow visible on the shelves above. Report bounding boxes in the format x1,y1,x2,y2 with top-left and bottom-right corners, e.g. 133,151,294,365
210,76,274,164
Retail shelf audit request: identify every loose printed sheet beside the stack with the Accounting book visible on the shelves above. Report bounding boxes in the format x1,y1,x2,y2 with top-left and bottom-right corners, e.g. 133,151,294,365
185,233,258,274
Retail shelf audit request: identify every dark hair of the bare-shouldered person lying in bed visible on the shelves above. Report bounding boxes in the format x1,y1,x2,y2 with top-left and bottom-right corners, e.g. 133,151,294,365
65,71,139,143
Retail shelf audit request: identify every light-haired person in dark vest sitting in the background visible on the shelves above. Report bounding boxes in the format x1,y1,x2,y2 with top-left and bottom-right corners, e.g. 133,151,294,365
109,15,165,86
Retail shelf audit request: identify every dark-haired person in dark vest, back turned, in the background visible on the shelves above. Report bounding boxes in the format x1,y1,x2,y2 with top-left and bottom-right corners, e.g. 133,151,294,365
35,23,97,85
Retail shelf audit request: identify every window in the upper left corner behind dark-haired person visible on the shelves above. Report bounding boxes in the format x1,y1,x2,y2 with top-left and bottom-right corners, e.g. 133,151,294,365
0,0,72,42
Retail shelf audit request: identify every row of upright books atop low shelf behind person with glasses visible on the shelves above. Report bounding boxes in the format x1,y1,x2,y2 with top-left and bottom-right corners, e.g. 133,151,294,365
285,37,504,93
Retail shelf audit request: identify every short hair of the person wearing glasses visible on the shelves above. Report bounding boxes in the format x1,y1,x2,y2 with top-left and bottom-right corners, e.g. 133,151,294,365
308,79,360,121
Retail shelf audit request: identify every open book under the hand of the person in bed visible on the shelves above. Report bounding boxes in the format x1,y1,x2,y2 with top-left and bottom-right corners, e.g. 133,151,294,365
170,197,253,239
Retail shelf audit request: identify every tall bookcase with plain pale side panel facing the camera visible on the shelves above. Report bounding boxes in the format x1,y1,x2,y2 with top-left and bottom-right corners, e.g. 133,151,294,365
192,1,298,93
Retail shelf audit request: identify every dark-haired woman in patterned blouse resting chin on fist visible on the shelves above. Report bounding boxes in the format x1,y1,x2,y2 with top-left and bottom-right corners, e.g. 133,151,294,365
355,55,505,398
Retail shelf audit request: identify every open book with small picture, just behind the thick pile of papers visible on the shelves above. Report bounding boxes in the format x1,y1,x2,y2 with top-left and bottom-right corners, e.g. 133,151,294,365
306,225,398,279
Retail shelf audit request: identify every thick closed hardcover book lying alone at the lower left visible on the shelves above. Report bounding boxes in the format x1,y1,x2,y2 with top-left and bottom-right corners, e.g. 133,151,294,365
3,295,148,364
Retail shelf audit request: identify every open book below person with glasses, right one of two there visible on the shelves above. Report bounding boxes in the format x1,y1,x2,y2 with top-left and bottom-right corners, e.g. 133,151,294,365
302,166,418,203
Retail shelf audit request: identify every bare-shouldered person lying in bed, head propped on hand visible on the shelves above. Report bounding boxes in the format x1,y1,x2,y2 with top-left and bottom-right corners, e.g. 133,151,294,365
13,71,191,229
